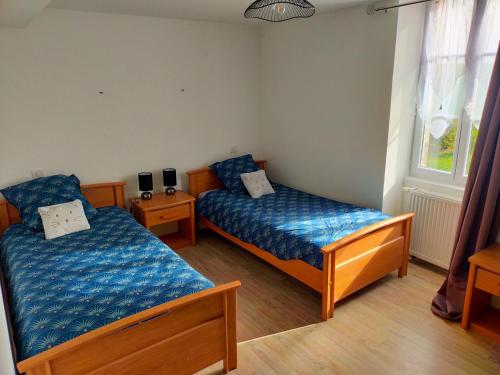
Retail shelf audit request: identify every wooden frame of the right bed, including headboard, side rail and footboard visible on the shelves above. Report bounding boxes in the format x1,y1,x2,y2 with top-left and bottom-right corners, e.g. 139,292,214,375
187,160,415,320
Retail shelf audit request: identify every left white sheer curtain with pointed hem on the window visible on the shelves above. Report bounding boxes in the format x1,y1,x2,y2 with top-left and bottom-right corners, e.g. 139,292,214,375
418,0,474,138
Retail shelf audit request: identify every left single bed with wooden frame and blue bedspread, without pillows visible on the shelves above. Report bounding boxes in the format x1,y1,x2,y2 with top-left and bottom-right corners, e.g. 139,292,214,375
0,183,239,374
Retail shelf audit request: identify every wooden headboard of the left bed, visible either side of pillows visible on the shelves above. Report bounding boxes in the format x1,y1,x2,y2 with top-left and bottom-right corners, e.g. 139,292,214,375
0,182,125,237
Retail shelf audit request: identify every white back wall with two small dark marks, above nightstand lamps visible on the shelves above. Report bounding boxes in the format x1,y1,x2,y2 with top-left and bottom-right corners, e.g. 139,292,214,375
0,10,261,195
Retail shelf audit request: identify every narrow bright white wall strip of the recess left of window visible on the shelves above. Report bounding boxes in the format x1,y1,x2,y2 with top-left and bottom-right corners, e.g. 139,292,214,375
382,4,426,215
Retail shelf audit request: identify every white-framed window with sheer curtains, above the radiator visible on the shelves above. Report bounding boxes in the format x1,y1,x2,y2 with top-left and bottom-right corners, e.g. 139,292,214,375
411,0,500,185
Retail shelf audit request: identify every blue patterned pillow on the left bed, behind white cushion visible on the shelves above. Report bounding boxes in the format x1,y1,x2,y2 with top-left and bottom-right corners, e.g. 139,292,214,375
0,175,97,231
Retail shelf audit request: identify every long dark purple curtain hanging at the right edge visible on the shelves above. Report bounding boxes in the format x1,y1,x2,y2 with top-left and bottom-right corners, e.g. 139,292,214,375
431,41,500,320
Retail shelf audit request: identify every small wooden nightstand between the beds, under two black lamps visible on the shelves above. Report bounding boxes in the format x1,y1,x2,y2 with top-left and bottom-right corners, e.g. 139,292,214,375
130,191,196,250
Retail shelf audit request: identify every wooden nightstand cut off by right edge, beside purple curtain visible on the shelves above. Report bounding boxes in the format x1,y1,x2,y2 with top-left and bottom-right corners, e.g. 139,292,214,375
462,244,500,342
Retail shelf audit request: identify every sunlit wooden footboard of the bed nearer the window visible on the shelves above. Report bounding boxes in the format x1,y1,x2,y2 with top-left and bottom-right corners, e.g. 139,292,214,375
321,213,415,320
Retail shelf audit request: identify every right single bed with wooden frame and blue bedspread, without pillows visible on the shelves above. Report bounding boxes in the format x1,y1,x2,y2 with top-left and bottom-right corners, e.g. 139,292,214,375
187,160,414,320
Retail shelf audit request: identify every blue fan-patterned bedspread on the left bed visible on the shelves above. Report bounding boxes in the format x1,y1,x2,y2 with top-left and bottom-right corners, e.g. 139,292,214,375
0,207,213,360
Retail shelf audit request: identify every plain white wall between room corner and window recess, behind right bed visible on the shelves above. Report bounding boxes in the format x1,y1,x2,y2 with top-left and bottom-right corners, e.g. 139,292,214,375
261,7,397,208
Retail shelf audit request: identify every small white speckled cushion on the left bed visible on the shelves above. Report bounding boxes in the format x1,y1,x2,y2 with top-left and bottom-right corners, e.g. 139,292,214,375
38,199,90,240
